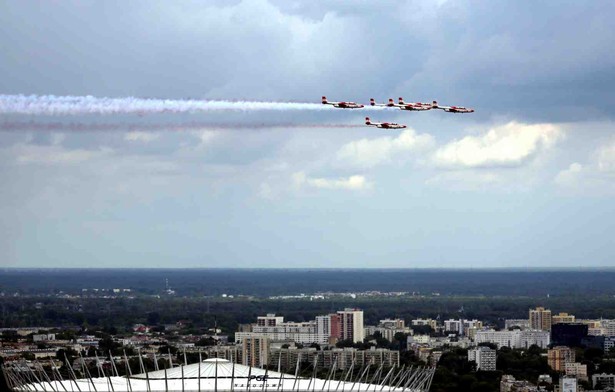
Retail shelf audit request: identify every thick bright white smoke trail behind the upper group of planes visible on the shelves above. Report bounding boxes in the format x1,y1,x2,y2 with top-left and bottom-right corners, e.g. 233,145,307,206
0,95,380,115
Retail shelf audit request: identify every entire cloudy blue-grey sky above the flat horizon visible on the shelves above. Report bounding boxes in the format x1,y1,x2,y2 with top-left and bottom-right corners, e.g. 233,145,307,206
0,0,615,268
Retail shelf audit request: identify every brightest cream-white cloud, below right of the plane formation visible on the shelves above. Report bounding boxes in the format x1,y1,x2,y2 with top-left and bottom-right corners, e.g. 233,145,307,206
433,122,563,169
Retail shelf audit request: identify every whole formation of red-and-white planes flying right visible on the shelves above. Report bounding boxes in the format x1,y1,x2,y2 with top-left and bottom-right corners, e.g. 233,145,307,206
322,95,474,129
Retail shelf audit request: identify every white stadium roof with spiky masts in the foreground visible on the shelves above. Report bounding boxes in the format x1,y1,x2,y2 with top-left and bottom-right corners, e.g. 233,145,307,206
3,358,435,392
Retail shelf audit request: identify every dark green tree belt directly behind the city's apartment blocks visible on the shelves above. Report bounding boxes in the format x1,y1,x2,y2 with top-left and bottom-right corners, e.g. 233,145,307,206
0,296,615,334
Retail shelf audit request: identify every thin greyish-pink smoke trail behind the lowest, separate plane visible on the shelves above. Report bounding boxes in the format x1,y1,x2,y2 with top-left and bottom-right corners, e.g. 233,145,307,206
0,121,365,132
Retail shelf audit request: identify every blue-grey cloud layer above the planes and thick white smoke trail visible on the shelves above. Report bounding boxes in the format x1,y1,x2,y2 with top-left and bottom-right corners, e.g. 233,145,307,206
0,0,615,121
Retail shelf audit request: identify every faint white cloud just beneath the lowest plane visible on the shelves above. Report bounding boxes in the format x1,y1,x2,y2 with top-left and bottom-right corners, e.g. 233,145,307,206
337,129,434,168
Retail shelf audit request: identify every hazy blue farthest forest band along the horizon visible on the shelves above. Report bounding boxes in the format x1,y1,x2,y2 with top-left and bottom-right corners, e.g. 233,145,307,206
0,269,615,297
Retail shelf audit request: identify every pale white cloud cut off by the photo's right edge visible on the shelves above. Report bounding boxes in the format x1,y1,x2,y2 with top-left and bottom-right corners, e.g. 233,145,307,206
554,140,615,193
